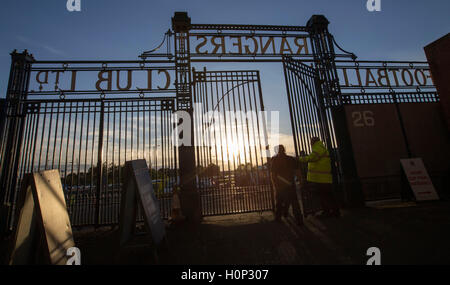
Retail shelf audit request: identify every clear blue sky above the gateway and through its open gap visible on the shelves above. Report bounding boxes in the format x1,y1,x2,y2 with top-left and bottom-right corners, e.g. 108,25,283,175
0,0,450,152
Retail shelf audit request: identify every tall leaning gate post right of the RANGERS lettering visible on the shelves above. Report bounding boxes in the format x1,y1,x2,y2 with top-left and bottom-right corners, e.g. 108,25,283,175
306,15,364,207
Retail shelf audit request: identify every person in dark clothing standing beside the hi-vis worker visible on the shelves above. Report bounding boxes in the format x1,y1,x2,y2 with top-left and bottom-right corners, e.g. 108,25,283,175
270,145,303,225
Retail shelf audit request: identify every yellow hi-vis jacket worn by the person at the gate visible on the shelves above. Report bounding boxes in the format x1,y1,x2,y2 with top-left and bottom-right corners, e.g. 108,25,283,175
300,141,333,183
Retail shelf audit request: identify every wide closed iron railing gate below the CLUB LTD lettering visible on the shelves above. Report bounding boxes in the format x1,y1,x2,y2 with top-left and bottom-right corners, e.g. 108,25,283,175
2,98,177,226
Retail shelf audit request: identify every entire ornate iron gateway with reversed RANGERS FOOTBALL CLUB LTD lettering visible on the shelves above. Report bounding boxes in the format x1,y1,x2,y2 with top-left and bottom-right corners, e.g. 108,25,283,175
0,12,439,234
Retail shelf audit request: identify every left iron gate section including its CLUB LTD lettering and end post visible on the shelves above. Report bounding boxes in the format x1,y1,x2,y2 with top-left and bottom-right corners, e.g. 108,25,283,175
0,54,179,231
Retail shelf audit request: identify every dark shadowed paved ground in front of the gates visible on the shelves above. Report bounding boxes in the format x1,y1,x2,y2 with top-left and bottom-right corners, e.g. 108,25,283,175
75,201,450,265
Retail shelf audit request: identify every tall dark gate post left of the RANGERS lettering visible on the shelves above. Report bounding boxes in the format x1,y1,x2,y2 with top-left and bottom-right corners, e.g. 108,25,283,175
172,12,201,222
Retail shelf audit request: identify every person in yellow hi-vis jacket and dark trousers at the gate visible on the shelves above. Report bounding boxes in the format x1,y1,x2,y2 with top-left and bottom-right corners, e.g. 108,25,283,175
299,137,340,217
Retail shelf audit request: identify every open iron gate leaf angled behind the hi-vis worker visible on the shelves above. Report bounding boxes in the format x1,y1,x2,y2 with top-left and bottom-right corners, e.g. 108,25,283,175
283,57,339,215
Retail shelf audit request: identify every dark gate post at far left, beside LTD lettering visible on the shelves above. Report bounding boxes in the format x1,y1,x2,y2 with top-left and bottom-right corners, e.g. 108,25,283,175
0,50,34,236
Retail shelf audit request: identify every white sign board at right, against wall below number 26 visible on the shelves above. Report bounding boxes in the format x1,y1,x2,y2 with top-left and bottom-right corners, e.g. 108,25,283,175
400,158,439,201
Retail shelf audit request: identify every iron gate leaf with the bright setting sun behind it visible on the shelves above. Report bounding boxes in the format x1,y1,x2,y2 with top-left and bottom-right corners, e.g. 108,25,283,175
193,70,274,216
